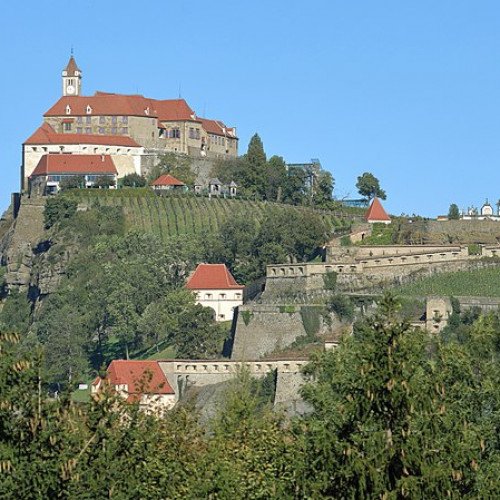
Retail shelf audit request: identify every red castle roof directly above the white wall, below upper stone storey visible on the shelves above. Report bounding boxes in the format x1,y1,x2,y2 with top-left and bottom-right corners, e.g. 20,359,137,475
24,123,141,148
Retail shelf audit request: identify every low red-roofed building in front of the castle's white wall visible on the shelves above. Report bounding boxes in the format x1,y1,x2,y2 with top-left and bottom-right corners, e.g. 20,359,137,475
30,154,117,194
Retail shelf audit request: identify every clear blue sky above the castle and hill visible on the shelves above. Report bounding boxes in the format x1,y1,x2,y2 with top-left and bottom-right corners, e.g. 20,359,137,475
0,0,500,216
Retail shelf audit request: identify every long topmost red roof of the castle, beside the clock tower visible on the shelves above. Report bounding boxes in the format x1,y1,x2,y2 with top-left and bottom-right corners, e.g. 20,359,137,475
44,92,195,121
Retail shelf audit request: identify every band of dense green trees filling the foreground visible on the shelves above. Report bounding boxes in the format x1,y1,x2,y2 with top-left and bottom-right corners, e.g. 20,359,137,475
0,296,500,499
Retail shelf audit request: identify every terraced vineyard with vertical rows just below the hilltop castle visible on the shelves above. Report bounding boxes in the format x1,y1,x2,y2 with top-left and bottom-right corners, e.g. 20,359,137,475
68,189,352,241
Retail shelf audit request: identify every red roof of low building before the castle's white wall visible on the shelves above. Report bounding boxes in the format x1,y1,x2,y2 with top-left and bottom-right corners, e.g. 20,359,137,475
31,154,117,177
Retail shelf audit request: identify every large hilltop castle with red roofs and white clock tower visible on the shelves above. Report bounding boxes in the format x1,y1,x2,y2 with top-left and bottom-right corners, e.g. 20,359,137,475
21,55,238,191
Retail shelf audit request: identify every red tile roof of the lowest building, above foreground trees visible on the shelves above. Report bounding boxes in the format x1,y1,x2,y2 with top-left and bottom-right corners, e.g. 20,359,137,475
102,360,175,399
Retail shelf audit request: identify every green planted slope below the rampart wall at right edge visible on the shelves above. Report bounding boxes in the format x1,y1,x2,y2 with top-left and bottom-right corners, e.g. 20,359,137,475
395,267,500,297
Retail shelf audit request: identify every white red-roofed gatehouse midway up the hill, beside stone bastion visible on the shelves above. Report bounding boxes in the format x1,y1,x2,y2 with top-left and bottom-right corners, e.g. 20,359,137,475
186,264,245,321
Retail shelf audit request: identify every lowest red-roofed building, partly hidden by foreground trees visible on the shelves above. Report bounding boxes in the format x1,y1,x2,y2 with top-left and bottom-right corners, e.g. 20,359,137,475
91,360,176,411
